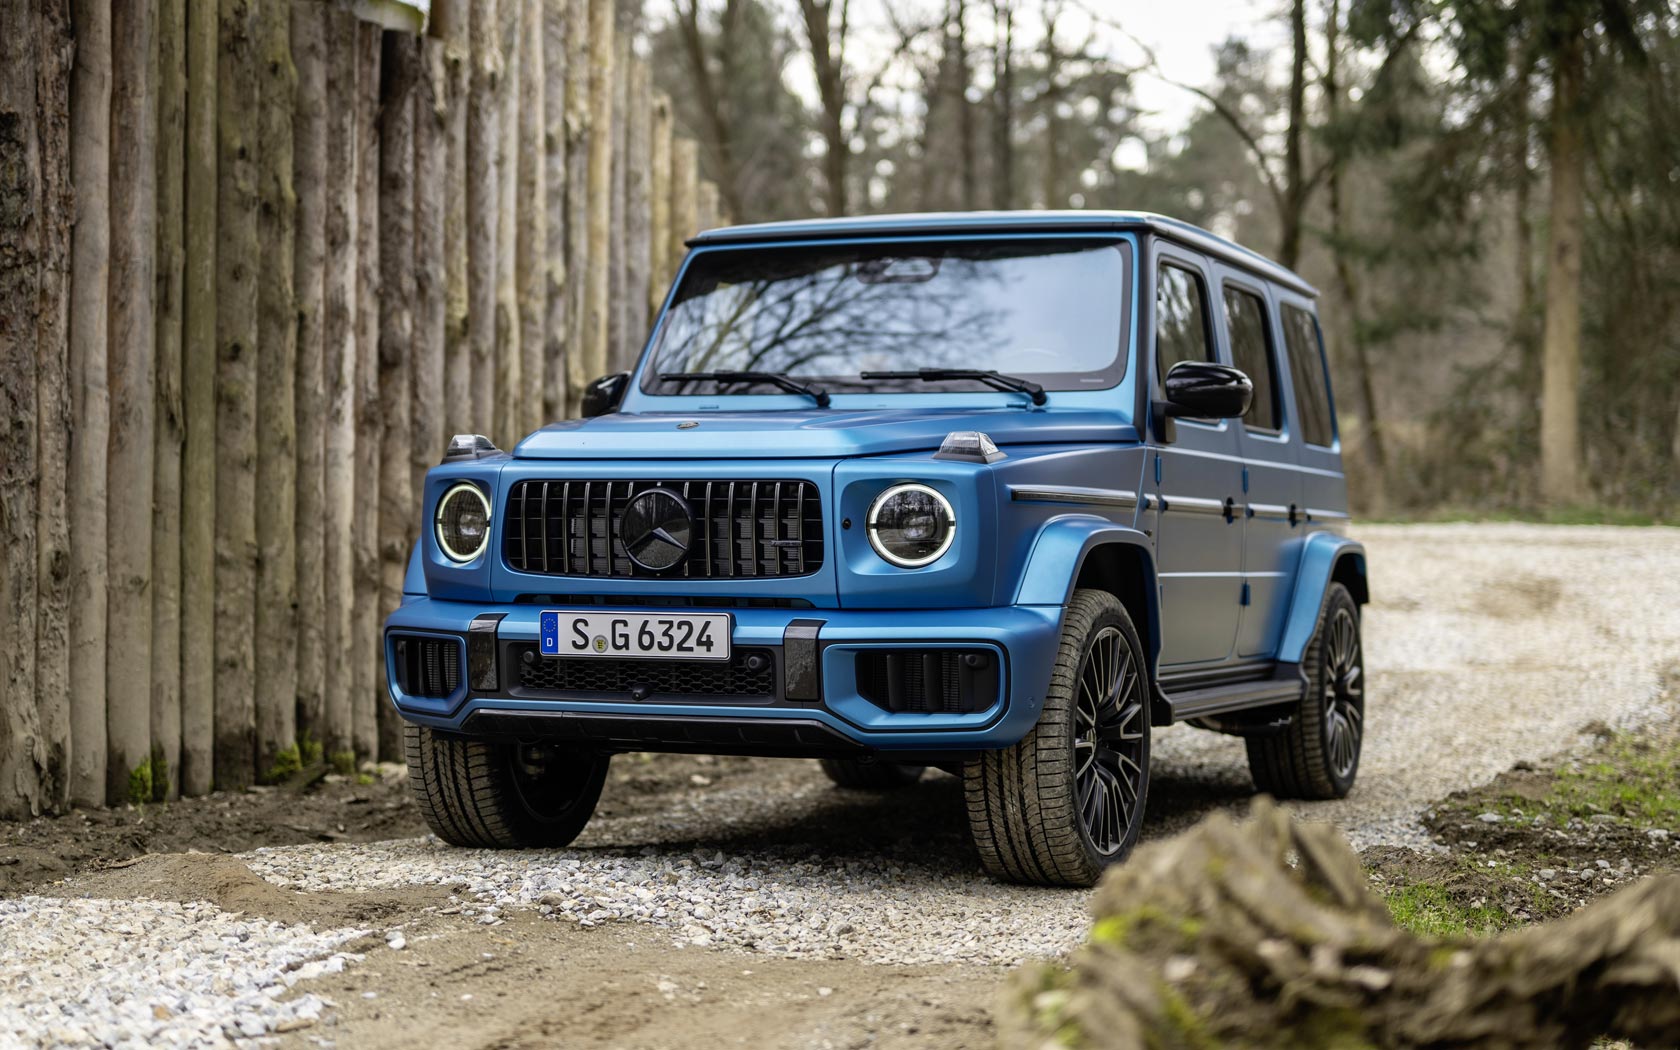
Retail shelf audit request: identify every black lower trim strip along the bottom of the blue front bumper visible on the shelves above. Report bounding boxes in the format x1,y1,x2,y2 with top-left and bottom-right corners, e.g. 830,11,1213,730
462,711,869,758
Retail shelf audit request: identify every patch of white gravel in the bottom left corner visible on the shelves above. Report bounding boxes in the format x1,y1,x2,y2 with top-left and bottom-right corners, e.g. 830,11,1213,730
0,897,363,1047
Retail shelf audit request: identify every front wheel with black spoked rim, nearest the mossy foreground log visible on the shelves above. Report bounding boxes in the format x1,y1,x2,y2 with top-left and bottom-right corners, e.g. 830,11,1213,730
963,590,1149,885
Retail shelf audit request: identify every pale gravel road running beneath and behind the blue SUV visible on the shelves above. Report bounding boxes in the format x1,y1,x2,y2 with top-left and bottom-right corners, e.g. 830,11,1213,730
0,524,1680,1047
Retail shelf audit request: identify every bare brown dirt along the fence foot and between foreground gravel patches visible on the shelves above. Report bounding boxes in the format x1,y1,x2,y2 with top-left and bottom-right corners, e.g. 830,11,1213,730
0,756,1005,1050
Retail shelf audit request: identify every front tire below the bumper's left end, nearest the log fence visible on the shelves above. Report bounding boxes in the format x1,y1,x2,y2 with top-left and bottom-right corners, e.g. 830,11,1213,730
403,722,610,850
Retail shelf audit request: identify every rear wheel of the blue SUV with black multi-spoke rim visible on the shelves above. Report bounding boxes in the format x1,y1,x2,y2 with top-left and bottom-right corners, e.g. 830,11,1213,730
1248,583,1364,800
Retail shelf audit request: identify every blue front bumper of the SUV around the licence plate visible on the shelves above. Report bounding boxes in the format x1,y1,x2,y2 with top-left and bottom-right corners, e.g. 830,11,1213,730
385,598,1062,756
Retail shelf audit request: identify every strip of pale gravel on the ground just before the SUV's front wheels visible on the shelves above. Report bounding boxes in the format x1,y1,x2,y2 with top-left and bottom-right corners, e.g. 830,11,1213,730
242,838,1087,963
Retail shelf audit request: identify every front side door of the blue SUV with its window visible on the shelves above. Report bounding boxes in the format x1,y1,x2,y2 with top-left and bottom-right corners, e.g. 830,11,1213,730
1146,240,1243,667
